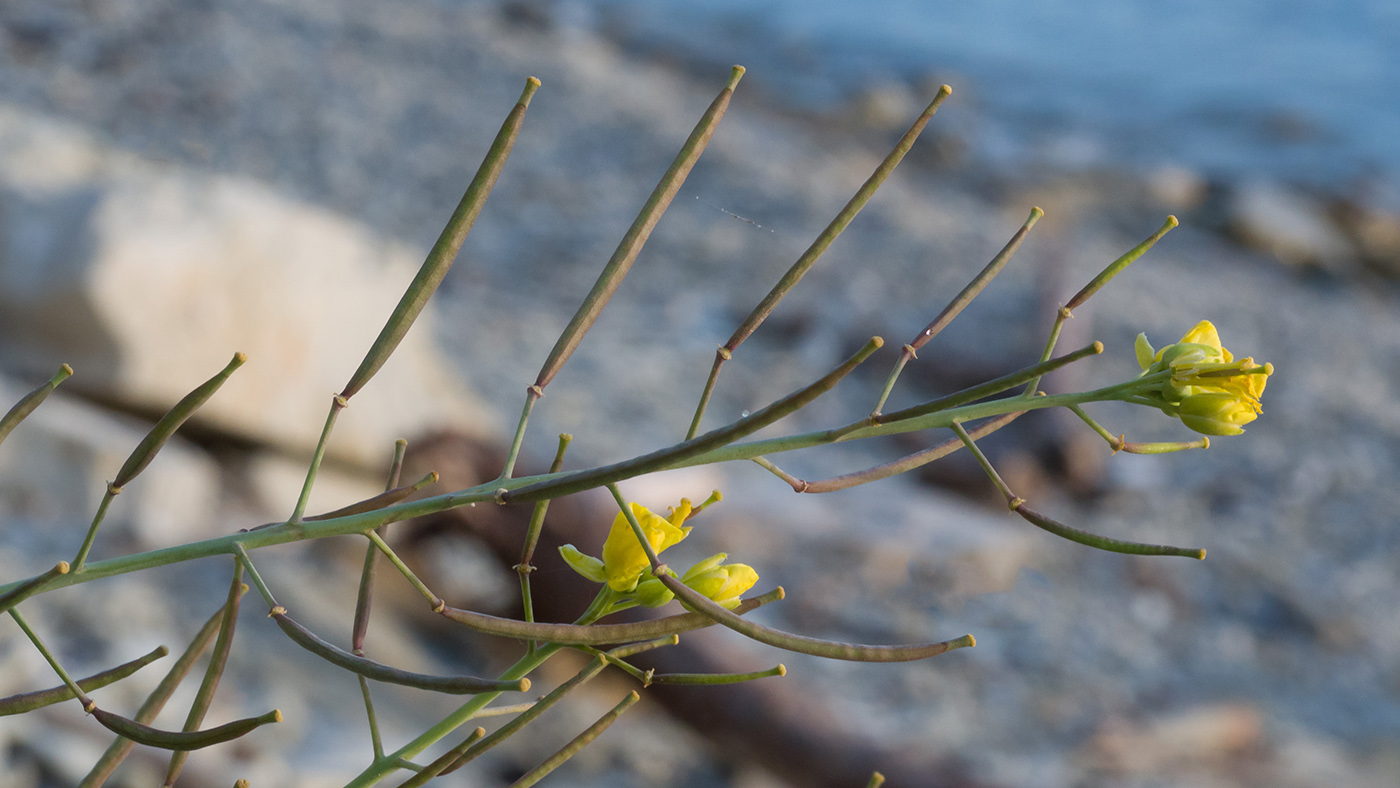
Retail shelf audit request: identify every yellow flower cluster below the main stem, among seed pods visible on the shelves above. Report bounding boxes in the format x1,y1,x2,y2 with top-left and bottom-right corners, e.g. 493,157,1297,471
559,491,759,610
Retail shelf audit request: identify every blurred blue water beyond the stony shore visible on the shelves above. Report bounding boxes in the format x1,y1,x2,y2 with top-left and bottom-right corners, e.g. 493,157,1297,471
596,0,1400,199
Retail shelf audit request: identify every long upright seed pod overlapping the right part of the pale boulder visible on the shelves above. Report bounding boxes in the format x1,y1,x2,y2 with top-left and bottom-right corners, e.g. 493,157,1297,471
340,77,539,399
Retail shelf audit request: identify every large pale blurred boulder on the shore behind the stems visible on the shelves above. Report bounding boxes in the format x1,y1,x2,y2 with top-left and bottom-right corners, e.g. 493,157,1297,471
0,104,494,466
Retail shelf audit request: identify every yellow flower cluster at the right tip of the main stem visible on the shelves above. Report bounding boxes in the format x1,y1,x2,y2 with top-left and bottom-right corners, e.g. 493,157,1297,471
1135,321,1274,435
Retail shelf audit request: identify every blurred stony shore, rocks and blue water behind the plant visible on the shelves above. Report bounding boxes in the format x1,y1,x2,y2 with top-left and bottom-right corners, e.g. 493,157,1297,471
0,0,1400,788
